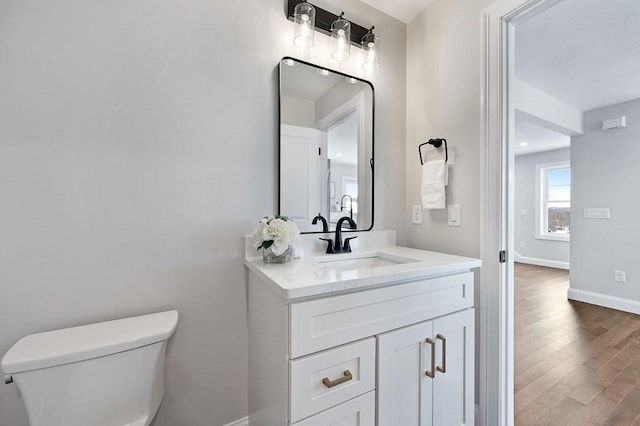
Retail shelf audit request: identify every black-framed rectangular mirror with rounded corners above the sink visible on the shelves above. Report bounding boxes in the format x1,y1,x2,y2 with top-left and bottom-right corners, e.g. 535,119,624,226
279,58,374,233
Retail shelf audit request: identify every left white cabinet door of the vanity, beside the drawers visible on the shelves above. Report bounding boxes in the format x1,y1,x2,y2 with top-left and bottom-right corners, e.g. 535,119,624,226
377,321,433,426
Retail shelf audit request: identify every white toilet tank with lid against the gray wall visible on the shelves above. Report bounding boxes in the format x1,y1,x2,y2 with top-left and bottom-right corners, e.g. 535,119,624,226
0,311,178,426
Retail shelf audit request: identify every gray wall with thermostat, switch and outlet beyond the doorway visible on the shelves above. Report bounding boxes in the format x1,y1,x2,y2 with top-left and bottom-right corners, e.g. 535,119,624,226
571,99,640,306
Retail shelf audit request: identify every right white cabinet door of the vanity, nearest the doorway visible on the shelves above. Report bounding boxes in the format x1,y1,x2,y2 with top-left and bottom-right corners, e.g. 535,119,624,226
433,309,475,426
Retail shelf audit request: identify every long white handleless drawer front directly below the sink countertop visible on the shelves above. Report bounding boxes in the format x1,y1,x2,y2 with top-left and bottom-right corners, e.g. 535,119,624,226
289,272,473,358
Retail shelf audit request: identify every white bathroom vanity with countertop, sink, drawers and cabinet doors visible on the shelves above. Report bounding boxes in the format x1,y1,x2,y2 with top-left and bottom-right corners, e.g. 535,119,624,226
245,231,480,426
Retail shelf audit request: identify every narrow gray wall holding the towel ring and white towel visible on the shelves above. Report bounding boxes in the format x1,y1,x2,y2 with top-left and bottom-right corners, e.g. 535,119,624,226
404,0,493,257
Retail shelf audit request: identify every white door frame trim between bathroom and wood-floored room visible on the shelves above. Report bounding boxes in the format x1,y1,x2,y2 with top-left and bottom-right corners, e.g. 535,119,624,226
478,0,561,426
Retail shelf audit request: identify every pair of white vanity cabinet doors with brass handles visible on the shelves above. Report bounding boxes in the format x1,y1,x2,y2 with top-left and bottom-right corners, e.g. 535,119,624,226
377,309,475,426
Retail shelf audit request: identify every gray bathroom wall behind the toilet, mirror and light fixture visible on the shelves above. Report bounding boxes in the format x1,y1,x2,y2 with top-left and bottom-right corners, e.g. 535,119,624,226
0,0,406,426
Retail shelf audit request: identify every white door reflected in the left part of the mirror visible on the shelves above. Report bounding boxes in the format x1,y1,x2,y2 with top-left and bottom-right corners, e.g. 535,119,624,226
280,125,322,231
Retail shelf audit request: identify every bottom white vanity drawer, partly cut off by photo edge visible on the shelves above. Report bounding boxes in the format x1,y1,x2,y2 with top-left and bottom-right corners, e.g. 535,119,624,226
292,391,376,426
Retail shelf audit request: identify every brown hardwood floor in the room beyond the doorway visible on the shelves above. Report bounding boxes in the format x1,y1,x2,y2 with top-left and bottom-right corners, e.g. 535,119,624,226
515,263,640,426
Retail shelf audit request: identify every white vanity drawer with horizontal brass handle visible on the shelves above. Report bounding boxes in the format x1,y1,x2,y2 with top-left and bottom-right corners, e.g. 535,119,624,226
289,338,376,423
